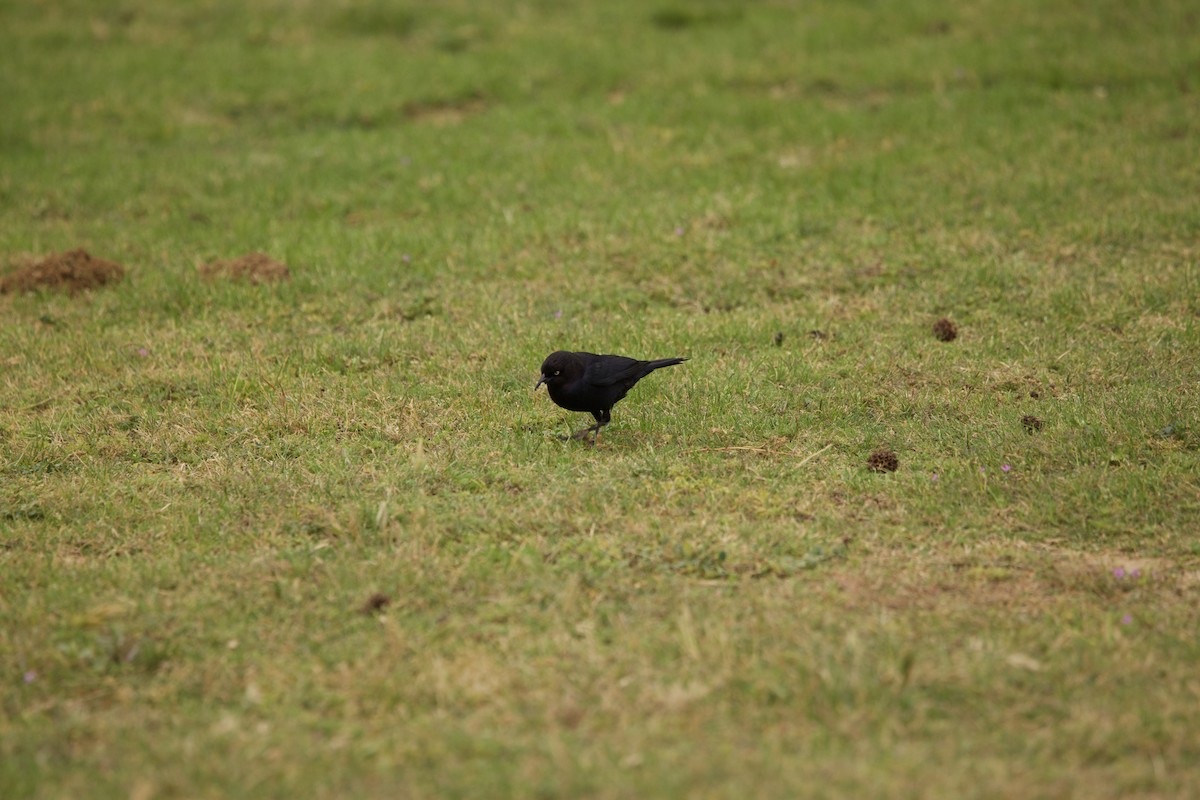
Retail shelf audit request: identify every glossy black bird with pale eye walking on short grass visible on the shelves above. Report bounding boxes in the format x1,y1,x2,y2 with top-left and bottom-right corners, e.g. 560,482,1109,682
533,350,688,444
